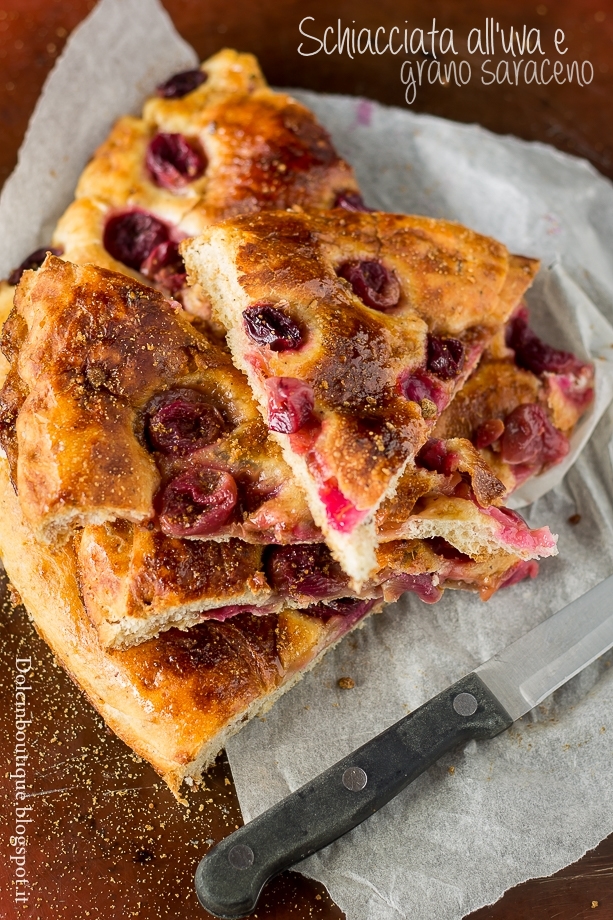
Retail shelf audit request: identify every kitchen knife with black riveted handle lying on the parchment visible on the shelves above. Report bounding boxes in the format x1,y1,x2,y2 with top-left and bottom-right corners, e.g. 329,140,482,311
195,575,613,918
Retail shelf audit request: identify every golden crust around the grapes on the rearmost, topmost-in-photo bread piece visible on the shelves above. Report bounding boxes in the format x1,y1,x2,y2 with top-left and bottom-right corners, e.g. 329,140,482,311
46,49,359,318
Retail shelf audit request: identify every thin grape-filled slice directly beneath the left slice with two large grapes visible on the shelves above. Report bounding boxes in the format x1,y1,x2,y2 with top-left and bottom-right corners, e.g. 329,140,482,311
75,491,556,648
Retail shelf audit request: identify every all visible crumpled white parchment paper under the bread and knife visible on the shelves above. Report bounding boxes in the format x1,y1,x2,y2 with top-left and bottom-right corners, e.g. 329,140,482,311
0,0,613,920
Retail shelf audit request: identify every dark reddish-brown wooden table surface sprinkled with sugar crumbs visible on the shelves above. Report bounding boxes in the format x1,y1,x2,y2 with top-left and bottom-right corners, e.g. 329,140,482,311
0,0,613,920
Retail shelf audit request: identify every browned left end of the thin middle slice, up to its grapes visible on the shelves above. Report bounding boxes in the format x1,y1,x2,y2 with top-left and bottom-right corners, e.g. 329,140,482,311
76,521,272,648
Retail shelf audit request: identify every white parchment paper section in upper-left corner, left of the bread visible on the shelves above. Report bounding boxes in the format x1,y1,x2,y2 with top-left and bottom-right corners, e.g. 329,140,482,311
0,0,198,278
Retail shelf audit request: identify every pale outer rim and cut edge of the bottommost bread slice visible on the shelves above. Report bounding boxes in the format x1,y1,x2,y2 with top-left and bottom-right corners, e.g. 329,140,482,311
0,460,382,798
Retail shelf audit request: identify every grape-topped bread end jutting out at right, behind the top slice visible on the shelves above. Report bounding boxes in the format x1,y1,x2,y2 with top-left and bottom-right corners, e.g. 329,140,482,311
435,305,594,492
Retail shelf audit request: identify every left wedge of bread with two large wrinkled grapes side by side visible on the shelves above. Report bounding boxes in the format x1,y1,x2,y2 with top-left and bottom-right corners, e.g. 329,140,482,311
0,256,318,543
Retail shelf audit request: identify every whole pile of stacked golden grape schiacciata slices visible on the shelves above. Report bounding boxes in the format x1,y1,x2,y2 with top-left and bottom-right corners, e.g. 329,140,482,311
0,52,592,791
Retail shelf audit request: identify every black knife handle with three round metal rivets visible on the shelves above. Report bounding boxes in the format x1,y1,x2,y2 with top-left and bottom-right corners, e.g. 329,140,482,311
195,674,513,920
